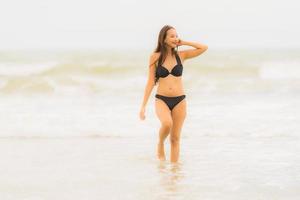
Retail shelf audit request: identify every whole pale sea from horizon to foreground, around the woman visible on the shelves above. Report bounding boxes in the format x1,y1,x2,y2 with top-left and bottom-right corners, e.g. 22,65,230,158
0,49,300,200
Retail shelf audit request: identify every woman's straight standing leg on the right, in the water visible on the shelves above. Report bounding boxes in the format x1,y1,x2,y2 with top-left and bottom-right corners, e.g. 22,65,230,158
170,99,186,162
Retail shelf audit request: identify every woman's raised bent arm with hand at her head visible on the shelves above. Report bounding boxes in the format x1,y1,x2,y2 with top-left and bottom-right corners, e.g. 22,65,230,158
177,39,208,60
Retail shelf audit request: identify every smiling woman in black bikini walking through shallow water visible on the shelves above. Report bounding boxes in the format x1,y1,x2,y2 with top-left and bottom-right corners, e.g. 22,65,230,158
140,25,208,162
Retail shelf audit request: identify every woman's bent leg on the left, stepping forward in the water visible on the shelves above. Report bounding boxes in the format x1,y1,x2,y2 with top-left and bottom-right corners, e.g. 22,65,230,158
155,99,173,160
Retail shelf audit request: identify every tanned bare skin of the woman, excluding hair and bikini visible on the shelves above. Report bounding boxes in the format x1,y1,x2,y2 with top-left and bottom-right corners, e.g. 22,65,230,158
139,28,208,163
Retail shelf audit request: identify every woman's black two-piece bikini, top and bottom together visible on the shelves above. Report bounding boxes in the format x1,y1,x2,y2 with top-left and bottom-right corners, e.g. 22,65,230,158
155,53,185,111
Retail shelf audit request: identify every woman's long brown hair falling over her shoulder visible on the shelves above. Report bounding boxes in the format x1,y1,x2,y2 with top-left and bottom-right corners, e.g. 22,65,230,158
154,25,178,84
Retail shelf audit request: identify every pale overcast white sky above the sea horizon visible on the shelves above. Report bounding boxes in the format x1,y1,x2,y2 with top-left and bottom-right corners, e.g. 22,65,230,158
0,0,300,49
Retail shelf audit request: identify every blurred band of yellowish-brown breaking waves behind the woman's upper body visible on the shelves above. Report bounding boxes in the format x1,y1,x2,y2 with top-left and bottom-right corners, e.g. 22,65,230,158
0,49,300,94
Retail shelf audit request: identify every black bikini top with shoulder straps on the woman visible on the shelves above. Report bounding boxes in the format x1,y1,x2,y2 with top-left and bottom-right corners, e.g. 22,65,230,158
155,53,183,79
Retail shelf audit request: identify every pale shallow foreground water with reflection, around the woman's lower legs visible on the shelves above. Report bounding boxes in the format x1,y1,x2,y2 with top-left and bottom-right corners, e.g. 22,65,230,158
0,136,300,200
